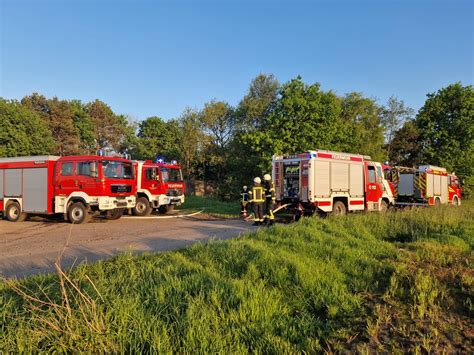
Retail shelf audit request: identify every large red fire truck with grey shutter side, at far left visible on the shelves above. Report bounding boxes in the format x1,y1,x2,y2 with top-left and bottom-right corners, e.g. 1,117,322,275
0,156,136,223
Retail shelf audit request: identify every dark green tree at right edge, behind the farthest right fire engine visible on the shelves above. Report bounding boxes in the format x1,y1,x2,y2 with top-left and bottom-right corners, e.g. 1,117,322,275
416,83,474,193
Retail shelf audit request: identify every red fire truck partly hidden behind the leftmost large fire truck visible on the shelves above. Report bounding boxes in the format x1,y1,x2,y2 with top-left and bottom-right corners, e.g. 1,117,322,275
132,160,185,216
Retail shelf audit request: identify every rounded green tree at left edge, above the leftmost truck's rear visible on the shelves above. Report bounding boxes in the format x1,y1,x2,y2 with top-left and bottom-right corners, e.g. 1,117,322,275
0,98,55,157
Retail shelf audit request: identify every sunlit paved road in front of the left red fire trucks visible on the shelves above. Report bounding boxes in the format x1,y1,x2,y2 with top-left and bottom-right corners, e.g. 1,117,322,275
0,215,256,277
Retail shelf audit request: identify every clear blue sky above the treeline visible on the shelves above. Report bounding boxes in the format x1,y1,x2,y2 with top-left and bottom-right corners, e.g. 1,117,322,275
0,0,474,119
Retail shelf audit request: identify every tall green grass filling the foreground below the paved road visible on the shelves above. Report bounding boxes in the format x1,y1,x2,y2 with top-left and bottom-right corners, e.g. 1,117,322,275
0,207,474,353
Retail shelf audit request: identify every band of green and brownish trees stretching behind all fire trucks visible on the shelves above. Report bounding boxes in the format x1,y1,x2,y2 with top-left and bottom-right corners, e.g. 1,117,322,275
0,74,474,196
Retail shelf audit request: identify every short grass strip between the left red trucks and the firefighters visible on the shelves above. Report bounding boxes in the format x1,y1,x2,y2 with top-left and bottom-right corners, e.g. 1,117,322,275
177,196,240,218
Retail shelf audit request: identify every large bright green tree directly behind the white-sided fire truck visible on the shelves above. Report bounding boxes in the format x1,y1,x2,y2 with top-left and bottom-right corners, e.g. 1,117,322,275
242,77,341,171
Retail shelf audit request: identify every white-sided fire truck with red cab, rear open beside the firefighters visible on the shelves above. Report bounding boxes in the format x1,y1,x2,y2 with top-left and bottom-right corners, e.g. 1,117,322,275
272,150,394,215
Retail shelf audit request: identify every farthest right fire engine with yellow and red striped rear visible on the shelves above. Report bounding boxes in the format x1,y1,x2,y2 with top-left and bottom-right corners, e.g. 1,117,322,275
391,165,461,206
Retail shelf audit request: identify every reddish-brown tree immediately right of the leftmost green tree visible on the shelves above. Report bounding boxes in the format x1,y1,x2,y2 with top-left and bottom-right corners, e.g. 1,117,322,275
21,93,80,155
